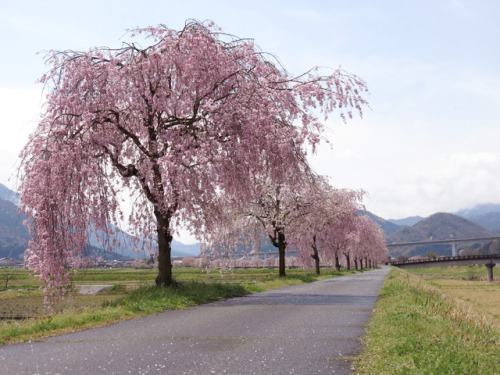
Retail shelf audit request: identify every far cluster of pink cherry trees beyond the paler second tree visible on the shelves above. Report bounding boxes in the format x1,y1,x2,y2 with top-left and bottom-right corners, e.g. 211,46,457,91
290,187,388,274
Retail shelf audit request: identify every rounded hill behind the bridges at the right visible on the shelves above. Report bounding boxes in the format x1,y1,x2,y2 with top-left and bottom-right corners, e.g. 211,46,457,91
387,213,498,257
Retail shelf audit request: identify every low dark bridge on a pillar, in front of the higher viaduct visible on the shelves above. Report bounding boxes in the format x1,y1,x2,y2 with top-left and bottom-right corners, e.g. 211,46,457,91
391,254,500,282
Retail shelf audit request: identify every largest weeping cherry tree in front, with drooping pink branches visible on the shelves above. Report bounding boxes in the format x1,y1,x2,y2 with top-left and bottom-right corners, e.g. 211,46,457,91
20,21,366,299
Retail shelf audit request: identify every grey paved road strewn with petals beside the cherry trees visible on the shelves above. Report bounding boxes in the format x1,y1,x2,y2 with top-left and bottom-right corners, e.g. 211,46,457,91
0,268,389,375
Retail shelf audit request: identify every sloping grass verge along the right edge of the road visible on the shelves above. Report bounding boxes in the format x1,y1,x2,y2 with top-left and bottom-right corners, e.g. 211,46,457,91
356,269,500,374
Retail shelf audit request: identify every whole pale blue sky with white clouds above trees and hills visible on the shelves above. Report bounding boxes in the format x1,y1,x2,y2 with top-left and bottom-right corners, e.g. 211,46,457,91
0,0,500,242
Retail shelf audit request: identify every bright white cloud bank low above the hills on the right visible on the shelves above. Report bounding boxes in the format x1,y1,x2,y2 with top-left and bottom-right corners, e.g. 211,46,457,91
369,153,500,218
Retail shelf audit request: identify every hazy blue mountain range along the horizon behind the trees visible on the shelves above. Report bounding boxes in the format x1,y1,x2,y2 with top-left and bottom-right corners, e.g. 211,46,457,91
0,184,500,259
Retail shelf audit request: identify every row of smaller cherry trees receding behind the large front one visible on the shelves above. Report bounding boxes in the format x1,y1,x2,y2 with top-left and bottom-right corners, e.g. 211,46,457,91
204,162,388,276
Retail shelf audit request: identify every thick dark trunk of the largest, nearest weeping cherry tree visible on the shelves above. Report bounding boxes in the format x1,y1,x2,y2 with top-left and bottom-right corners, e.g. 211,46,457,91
156,214,173,286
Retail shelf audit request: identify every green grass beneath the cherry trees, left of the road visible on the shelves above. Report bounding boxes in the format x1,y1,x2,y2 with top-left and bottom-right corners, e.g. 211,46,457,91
0,268,358,345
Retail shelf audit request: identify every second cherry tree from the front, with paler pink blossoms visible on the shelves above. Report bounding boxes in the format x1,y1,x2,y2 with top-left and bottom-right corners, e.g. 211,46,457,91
202,159,319,276
